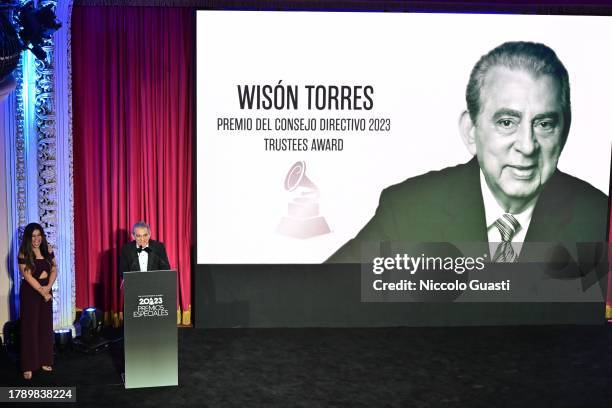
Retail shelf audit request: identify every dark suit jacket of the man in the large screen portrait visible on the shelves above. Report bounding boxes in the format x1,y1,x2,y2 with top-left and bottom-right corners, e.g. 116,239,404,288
328,157,608,263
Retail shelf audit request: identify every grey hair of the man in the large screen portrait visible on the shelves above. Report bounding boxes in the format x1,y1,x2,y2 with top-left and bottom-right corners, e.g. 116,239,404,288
465,41,572,138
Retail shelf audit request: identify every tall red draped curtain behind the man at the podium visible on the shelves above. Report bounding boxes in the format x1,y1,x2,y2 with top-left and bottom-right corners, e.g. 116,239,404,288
71,6,194,325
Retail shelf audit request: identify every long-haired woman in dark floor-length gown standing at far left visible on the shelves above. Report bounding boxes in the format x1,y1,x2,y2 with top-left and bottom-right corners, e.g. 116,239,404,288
17,223,57,380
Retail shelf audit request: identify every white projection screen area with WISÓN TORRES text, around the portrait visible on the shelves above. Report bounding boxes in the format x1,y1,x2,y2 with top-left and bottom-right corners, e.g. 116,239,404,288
195,10,612,264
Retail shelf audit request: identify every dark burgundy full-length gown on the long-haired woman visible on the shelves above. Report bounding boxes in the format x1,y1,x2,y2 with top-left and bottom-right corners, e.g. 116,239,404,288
18,254,53,371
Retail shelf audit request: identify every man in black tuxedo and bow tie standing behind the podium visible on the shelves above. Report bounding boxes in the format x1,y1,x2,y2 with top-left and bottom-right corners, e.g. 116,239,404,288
119,221,170,277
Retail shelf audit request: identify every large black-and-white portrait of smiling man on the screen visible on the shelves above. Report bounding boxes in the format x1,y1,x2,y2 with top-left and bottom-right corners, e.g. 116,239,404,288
328,42,608,262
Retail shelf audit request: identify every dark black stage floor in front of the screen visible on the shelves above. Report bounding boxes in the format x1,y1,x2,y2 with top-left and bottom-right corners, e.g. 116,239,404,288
0,326,612,408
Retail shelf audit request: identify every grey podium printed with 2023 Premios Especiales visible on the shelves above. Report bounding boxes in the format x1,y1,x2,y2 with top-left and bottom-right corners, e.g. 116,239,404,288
123,271,178,388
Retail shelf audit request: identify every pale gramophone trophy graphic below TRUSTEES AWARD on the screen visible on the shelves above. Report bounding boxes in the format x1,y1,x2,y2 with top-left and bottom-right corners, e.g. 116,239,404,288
276,161,330,239
